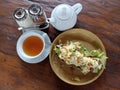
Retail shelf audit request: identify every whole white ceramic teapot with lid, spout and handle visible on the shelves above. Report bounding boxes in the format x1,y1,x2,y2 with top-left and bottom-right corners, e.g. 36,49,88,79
48,3,82,31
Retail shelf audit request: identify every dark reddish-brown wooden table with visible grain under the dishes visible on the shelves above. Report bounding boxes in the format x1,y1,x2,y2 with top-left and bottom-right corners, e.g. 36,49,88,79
0,0,120,90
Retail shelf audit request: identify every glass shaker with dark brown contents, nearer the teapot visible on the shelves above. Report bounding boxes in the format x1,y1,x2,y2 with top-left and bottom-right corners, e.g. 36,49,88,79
28,4,49,29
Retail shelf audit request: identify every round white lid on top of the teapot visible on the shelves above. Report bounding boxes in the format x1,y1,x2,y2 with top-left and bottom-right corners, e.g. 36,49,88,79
55,4,72,20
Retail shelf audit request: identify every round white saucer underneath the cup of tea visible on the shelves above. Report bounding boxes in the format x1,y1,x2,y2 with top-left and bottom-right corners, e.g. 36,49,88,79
16,29,51,63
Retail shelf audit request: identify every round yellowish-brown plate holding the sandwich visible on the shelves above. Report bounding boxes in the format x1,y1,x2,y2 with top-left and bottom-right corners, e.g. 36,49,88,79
49,29,106,85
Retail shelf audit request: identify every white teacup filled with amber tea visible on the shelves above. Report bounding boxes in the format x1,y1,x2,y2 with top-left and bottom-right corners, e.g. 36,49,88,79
17,32,45,60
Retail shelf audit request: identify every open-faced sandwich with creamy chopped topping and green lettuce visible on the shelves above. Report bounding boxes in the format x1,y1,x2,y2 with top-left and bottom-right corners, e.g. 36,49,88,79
54,41,107,74
